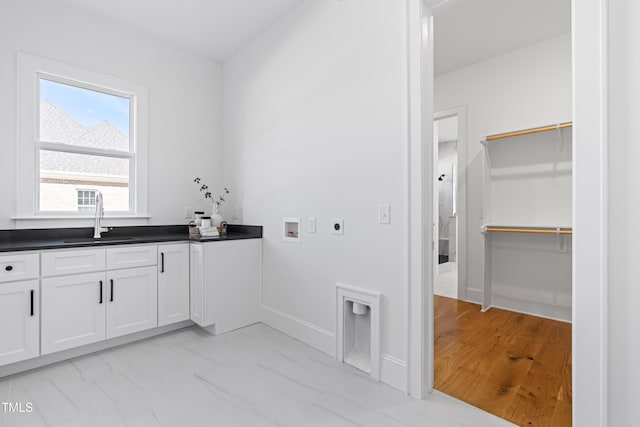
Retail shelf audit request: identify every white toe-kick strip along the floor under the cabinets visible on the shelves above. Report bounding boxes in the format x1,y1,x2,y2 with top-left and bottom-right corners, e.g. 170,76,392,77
0,320,194,378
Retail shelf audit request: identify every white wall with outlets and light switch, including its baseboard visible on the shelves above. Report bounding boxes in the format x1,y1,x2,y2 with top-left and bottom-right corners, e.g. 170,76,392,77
223,0,408,388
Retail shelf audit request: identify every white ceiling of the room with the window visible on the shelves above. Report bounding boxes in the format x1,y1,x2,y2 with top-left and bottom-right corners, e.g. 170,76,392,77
57,0,304,61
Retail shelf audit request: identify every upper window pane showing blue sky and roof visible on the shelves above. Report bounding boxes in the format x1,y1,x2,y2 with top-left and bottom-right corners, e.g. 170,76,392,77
40,79,131,151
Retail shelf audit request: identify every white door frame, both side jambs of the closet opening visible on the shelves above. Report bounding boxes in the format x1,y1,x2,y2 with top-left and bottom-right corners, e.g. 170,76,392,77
406,0,610,426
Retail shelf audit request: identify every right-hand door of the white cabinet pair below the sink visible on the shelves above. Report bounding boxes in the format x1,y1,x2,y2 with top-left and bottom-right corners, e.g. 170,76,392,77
107,266,158,338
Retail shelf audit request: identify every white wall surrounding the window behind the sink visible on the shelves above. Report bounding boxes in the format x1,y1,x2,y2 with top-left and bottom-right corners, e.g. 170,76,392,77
0,0,222,228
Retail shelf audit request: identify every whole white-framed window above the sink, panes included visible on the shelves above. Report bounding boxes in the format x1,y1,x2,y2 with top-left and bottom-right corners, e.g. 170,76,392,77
18,53,146,218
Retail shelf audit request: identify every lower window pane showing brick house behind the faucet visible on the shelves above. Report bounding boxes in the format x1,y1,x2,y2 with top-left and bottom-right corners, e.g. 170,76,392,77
40,150,130,212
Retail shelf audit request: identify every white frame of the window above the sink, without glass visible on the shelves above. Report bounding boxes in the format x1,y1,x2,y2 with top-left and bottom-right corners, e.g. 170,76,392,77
14,52,148,220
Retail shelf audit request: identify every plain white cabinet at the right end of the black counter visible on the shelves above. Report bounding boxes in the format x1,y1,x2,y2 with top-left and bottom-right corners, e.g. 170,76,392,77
190,239,262,334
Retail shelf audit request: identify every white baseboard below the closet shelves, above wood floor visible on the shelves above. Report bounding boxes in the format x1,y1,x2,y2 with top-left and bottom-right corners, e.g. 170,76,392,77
491,291,572,323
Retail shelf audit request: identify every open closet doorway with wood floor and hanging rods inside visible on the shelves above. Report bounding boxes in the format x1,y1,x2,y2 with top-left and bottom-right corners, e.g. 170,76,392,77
425,0,573,427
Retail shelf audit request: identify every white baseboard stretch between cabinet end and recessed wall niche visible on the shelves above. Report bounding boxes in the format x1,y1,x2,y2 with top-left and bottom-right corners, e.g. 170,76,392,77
260,304,336,357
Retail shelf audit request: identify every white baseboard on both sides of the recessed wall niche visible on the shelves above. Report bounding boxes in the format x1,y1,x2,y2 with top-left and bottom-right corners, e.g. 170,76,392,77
260,304,407,392
